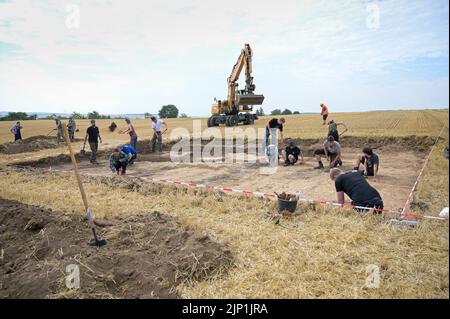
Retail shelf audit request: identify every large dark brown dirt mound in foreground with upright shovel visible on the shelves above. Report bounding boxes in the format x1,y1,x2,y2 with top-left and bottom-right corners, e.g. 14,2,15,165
0,199,232,298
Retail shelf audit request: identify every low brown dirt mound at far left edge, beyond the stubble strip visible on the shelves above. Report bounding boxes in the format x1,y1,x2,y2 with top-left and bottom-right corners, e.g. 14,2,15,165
0,135,79,154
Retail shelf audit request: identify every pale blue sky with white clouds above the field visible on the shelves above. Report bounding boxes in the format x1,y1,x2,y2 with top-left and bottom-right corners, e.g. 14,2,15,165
0,0,449,116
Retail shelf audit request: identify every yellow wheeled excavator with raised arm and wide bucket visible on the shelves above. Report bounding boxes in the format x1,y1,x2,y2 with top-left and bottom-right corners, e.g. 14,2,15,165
208,44,264,127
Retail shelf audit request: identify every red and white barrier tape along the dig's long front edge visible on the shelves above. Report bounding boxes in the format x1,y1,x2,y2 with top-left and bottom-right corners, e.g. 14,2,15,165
44,167,448,221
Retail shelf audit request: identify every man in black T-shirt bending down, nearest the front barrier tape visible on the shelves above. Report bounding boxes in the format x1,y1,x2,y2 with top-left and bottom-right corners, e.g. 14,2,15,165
330,168,384,213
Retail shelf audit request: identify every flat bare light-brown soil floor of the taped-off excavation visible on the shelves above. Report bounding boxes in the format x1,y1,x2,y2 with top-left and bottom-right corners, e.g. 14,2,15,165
9,136,434,210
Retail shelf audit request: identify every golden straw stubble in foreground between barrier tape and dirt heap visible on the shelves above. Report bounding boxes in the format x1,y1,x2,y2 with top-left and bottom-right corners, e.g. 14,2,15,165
0,168,449,298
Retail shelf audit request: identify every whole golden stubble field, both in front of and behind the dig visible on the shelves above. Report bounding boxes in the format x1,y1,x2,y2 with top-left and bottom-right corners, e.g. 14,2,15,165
0,110,449,298
